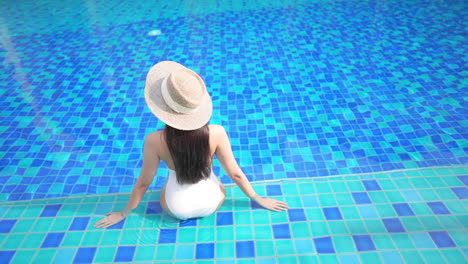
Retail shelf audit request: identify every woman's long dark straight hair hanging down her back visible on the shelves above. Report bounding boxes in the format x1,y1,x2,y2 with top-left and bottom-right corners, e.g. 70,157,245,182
164,124,211,184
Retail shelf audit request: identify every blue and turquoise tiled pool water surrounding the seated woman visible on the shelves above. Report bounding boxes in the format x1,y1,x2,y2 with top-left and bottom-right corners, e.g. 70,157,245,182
0,0,468,263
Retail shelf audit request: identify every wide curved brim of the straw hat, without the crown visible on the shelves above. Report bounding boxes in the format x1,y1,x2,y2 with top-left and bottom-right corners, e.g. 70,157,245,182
145,61,213,130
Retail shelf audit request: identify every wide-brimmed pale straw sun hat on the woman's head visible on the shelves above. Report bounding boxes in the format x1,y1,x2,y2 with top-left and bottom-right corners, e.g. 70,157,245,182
145,61,213,130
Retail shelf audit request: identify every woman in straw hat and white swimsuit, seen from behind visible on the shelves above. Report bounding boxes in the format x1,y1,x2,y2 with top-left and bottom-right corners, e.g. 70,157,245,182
95,61,288,227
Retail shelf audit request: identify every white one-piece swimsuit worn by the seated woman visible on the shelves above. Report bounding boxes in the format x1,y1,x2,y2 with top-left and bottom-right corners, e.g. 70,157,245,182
165,170,224,220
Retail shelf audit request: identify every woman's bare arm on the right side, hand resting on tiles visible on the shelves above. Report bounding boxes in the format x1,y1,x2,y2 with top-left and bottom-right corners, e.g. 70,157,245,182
214,126,288,212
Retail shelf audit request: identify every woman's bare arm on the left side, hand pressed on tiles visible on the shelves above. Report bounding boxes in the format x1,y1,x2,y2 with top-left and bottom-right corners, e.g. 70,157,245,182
94,132,160,228
